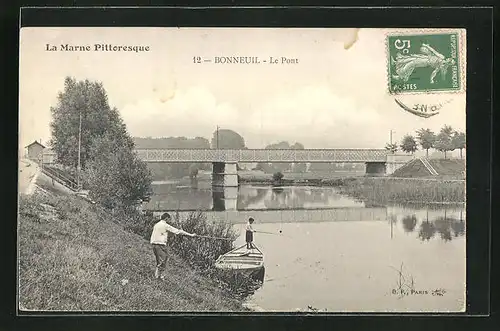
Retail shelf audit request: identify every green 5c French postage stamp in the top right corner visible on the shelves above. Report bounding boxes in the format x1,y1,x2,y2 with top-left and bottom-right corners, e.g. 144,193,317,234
387,32,463,94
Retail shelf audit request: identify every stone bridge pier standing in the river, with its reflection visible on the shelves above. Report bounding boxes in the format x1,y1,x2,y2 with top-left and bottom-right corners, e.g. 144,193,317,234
212,162,238,211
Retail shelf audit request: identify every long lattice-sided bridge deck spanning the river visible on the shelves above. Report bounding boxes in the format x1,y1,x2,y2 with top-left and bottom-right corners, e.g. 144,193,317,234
136,149,387,163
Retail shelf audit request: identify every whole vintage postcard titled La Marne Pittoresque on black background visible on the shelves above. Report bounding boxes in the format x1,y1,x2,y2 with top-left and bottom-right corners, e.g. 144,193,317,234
18,27,467,314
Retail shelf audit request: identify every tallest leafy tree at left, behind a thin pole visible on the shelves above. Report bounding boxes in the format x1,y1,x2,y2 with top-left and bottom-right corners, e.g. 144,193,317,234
50,77,133,168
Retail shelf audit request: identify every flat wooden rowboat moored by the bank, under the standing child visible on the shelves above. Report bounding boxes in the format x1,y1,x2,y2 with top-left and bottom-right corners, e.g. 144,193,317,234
215,244,265,282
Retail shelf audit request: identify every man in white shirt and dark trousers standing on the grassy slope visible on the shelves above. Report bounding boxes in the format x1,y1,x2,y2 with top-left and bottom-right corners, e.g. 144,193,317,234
150,213,196,279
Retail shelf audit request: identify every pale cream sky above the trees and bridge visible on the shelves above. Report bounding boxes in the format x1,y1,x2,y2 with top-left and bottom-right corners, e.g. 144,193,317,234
19,27,465,152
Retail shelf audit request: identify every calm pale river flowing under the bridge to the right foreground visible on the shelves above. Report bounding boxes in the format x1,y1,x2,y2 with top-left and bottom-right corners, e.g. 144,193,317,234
144,184,466,312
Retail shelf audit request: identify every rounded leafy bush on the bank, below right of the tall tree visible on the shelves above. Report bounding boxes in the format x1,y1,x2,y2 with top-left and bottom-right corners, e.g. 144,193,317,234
83,134,151,211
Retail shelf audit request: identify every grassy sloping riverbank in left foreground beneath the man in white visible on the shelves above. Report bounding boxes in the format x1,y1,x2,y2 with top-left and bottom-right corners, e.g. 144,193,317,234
18,188,242,311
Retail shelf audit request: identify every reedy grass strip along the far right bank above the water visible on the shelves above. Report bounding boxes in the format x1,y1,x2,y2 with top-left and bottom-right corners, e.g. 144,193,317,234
330,177,465,203
